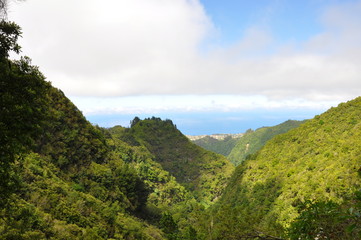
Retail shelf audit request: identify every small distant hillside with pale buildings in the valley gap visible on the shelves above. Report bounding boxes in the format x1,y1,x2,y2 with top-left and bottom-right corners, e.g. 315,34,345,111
193,136,239,156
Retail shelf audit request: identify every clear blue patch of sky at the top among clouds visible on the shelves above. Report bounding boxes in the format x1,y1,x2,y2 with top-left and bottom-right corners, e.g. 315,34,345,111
201,0,324,45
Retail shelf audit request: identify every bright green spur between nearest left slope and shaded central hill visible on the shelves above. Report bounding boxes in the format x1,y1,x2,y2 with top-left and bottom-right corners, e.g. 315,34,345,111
104,126,204,236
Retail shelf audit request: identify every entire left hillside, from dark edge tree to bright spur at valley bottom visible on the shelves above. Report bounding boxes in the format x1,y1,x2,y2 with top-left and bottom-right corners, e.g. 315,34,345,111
0,21,203,239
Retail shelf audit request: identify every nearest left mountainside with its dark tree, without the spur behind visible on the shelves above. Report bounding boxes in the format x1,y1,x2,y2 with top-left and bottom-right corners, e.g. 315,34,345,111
0,44,159,239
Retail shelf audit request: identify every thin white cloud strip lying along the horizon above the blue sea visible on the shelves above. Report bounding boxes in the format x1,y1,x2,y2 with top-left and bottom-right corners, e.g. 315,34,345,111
71,95,340,116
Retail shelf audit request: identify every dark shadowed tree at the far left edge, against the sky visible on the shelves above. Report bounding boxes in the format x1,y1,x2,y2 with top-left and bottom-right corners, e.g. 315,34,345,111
0,20,49,207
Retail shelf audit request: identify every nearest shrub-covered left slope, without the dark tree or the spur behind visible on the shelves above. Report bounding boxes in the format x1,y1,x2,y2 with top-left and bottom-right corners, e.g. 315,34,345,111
0,81,169,239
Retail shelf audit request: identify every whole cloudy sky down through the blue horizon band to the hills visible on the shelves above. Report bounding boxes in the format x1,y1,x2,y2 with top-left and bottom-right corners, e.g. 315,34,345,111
9,0,361,135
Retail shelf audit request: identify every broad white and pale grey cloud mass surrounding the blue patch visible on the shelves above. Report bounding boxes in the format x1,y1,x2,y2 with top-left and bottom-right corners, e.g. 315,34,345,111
7,0,361,104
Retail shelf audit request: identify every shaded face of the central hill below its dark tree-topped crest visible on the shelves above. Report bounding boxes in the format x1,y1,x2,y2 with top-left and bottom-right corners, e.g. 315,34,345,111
110,117,234,205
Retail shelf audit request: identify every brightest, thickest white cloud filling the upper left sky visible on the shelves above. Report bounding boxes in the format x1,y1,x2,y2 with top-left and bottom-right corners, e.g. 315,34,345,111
12,0,212,96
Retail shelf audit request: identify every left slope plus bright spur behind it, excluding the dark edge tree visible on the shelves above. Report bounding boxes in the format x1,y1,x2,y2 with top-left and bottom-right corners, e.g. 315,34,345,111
0,72,208,239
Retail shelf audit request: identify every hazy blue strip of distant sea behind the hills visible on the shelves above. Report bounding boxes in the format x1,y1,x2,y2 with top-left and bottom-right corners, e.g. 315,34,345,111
86,109,327,135
